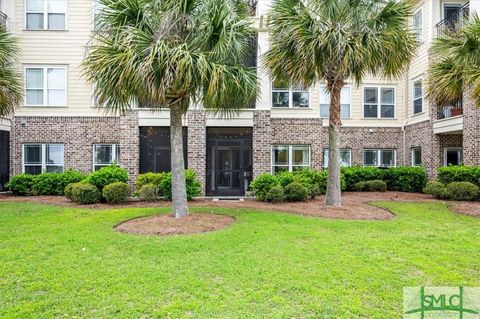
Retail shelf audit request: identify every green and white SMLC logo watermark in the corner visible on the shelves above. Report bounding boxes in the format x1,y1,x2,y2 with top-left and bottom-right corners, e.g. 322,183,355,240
403,287,480,319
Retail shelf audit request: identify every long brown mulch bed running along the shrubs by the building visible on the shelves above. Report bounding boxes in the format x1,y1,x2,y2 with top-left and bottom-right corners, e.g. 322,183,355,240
0,192,440,220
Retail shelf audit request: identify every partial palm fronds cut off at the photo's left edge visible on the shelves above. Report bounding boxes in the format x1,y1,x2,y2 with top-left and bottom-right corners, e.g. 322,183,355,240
0,27,23,117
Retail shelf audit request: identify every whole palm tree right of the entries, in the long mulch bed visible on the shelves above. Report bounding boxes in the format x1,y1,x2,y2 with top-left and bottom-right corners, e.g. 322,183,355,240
264,0,416,206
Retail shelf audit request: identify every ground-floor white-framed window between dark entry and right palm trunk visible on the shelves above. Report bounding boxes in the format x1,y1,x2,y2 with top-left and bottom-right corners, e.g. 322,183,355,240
272,145,310,173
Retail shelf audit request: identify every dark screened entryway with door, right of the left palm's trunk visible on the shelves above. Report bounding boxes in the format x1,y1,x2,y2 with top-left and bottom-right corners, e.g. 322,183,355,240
206,128,252,196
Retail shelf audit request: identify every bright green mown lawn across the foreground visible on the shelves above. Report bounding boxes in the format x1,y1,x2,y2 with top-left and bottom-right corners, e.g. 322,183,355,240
0,203,480,319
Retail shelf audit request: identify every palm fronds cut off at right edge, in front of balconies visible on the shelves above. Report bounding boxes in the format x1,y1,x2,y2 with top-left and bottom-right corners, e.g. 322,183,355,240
427,13,480,106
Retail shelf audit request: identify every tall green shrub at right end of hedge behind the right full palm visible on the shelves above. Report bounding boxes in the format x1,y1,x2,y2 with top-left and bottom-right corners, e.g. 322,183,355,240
381,166,428,193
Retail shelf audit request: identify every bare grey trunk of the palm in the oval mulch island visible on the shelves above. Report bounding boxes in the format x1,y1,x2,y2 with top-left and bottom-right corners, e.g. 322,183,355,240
170,103,188,218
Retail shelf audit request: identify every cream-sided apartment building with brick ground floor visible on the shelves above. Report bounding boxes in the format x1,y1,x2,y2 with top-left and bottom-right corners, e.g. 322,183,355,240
0,0,480,196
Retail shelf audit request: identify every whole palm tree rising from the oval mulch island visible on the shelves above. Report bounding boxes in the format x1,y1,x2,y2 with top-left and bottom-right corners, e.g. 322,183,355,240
83,0,258,218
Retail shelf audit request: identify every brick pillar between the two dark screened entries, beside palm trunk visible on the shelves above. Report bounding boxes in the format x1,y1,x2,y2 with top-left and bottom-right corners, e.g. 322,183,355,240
187,110,207,195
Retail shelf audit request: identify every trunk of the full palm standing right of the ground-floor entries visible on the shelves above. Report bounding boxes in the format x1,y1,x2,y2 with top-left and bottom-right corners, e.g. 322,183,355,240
325,81,343,207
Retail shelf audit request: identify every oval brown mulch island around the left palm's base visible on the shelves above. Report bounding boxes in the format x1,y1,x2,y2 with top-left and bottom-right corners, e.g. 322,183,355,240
114,213,235,236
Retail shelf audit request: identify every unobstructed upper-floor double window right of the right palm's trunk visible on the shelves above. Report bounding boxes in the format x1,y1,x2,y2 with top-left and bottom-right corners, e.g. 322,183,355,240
363,87,395,118
